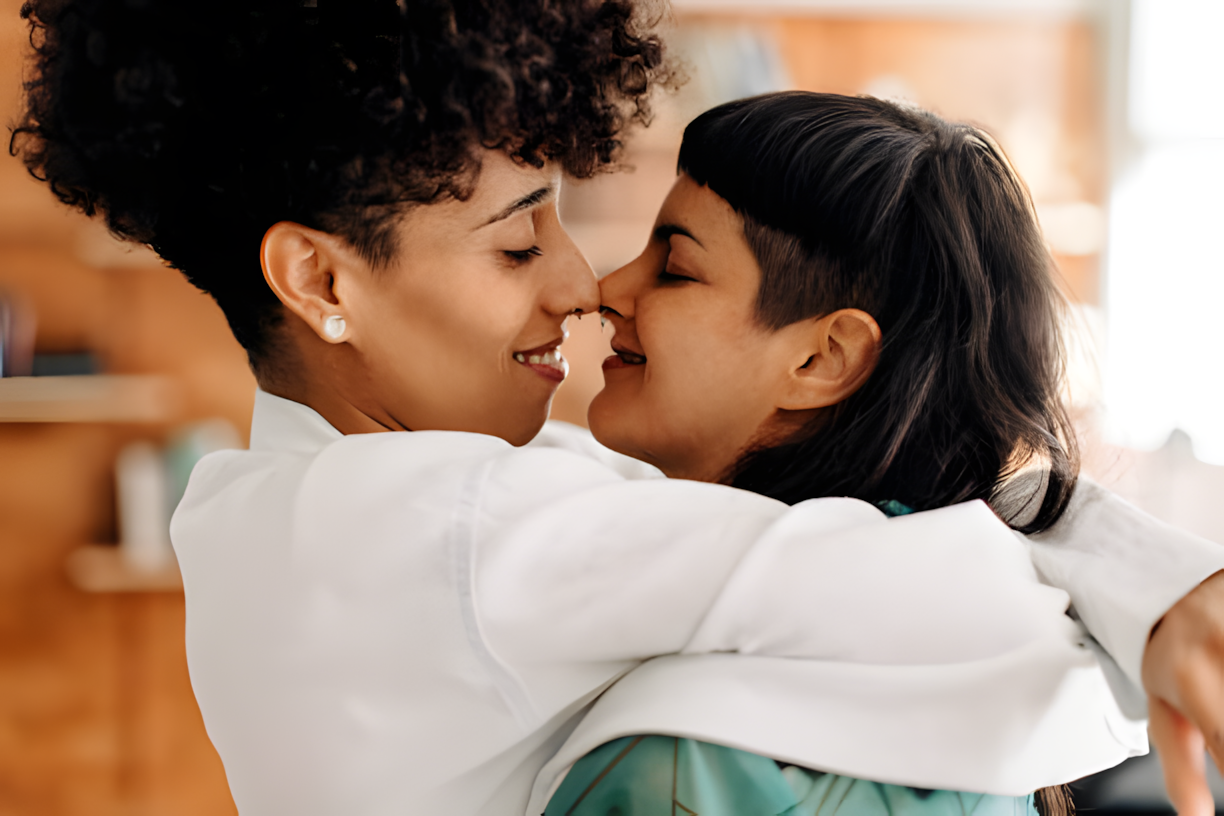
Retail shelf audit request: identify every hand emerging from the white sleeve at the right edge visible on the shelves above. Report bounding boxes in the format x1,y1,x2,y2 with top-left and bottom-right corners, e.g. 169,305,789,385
1143,573,1224,816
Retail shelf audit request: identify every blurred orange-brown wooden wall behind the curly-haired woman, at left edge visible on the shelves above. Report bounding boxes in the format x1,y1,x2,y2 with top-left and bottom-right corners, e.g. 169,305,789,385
0,0,253,797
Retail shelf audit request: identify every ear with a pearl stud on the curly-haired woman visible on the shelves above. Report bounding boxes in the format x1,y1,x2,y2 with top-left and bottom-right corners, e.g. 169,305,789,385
259,221,355,343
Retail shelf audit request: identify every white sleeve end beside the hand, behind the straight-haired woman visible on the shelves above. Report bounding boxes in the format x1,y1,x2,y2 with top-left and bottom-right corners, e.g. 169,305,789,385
1029,478,1224,688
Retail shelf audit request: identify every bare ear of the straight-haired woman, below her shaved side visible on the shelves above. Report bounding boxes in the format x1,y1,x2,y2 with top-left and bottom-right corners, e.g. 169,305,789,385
777,308,883,411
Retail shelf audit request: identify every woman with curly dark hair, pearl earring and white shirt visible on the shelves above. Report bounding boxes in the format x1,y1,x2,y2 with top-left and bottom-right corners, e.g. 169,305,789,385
11,0,1224,816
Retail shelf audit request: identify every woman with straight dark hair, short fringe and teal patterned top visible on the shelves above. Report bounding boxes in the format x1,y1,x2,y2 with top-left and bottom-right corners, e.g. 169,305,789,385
546,92,1189,816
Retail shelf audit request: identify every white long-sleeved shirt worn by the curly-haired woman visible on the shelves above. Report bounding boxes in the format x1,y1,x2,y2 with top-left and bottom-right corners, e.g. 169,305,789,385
171,393,1224,816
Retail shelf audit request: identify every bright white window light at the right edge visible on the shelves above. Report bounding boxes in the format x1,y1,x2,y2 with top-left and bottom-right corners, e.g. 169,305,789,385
1104,0,1224,464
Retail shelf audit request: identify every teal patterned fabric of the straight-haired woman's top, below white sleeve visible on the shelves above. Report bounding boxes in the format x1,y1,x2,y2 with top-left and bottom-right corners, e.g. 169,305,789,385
543,736,1037,816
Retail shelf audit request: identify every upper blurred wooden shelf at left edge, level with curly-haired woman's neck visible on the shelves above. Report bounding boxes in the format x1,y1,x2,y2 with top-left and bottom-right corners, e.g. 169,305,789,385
0,374,177,422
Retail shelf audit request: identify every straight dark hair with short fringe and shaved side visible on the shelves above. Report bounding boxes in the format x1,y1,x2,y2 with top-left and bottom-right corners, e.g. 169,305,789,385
679,92,1078,532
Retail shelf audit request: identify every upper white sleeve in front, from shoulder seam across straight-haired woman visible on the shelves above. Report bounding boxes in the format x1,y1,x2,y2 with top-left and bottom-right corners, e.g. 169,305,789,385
472,449,1071,696
